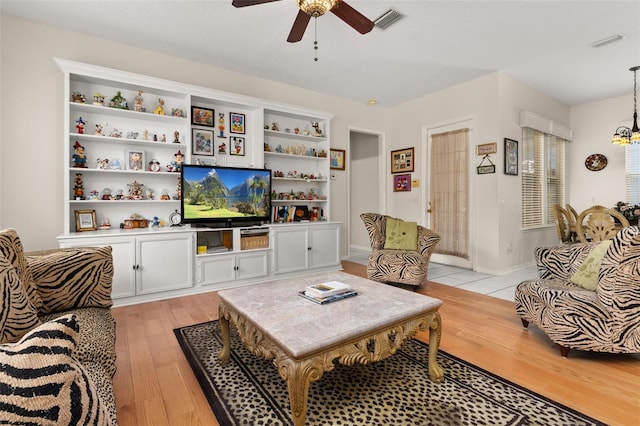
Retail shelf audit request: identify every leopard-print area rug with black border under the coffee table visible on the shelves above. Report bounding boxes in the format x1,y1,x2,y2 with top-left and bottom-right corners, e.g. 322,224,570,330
174,321,604,426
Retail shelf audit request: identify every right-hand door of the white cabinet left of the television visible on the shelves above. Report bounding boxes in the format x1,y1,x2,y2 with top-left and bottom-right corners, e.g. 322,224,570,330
135,233,195,294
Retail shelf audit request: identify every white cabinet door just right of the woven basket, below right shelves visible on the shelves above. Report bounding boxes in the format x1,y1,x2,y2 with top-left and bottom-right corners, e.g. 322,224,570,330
272,225,309,274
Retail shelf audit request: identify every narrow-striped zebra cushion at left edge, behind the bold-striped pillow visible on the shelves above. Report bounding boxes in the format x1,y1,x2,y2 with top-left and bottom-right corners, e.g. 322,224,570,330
0,254,40,343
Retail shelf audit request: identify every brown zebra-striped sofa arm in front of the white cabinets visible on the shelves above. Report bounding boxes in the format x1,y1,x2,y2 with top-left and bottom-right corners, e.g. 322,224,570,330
26,247,113,314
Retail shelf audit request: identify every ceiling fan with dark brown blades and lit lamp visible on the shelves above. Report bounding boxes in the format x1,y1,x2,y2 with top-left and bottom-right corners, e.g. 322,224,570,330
231,0,374,43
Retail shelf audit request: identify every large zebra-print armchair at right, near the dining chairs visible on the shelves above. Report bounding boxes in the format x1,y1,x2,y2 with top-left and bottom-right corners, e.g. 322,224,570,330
515,226,640,357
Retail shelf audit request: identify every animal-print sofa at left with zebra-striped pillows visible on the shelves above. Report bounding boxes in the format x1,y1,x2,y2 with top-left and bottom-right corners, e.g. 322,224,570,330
0,229,116,425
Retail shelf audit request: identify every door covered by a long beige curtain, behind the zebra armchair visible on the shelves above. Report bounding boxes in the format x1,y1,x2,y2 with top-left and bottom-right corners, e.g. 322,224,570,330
423,118,473,269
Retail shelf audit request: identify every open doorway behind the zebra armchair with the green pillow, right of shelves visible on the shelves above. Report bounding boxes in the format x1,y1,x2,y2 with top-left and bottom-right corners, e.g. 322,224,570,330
347,128,386,258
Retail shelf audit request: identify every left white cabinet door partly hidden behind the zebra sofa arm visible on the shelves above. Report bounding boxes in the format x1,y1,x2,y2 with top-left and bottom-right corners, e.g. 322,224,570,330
60,237,136,299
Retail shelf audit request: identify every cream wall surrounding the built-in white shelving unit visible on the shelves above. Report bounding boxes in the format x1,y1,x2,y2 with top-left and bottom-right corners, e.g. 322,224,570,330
0,15,385,253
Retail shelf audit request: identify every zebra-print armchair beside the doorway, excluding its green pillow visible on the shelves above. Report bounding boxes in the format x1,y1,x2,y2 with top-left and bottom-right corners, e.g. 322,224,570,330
360,213,440,290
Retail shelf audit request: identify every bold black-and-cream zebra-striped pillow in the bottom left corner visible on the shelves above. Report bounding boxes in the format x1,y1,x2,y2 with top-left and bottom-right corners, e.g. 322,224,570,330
0,315,111,425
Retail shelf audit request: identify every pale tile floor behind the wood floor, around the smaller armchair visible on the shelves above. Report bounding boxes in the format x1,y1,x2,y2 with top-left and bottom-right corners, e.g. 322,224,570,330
349,252,538,302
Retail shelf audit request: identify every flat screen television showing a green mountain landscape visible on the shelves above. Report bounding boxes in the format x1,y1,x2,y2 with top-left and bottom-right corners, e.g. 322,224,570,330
180,164,271,227
